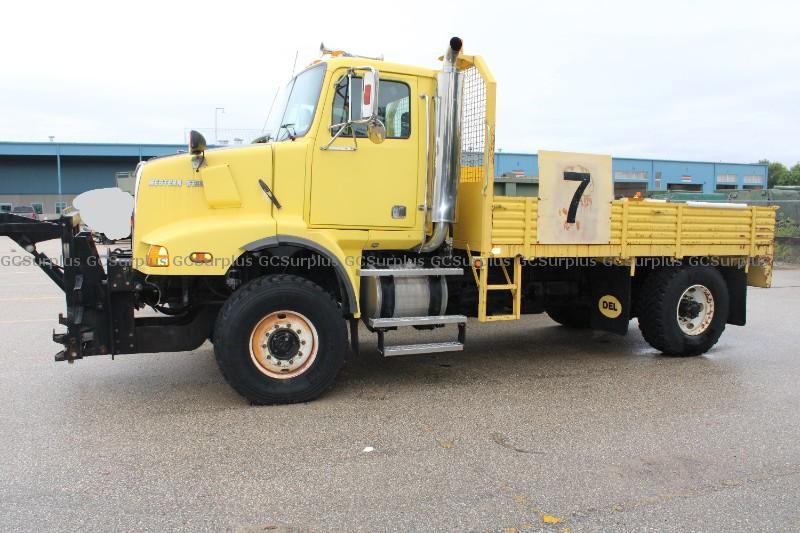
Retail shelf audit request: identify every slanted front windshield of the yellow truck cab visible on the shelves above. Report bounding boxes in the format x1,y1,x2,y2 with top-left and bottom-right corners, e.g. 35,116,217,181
264,63,325,141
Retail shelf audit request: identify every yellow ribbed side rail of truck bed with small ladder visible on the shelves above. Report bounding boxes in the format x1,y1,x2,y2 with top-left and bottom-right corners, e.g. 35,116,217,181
468,196,777,321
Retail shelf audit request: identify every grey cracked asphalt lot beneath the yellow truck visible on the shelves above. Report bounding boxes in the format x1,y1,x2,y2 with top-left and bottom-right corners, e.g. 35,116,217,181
0,238,800,531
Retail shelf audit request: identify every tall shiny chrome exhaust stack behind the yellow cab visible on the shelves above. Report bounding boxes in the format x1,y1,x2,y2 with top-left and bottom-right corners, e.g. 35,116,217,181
419,37,464,252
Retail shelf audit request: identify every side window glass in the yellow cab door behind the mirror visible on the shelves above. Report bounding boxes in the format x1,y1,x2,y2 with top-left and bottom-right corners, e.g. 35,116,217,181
331,76,411,139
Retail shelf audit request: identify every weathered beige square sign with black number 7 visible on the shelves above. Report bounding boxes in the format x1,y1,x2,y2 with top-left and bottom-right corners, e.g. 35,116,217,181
537,151,614,244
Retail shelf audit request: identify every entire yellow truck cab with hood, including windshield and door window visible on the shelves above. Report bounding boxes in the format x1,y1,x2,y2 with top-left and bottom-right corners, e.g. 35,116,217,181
133,53,446,300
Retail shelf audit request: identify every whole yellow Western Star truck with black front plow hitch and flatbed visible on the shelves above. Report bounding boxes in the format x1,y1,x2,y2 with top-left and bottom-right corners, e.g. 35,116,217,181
0,38,775,404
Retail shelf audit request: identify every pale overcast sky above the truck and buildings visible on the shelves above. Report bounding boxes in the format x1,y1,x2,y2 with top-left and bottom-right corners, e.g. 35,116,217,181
0,0,800,164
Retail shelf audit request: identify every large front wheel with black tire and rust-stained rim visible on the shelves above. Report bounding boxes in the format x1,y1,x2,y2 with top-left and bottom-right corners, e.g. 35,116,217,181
214,274,347,405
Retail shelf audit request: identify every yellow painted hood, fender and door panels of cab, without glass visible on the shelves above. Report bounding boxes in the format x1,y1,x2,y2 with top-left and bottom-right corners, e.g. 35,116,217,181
133,58,435,316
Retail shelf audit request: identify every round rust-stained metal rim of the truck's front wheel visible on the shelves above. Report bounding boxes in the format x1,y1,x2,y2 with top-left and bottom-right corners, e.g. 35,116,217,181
250,311,319,379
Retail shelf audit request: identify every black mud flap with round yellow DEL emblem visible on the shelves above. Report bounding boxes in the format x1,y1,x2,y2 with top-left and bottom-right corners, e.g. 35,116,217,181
590,265,631,335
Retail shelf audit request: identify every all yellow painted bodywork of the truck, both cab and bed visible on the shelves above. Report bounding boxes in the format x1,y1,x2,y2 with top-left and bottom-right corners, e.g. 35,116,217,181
133,52,775,319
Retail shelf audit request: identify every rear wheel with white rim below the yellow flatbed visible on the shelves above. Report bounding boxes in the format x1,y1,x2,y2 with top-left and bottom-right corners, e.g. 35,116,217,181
637,267,729,357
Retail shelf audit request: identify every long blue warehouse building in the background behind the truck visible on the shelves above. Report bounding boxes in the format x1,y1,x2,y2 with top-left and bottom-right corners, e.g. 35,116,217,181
0,139,767,214
